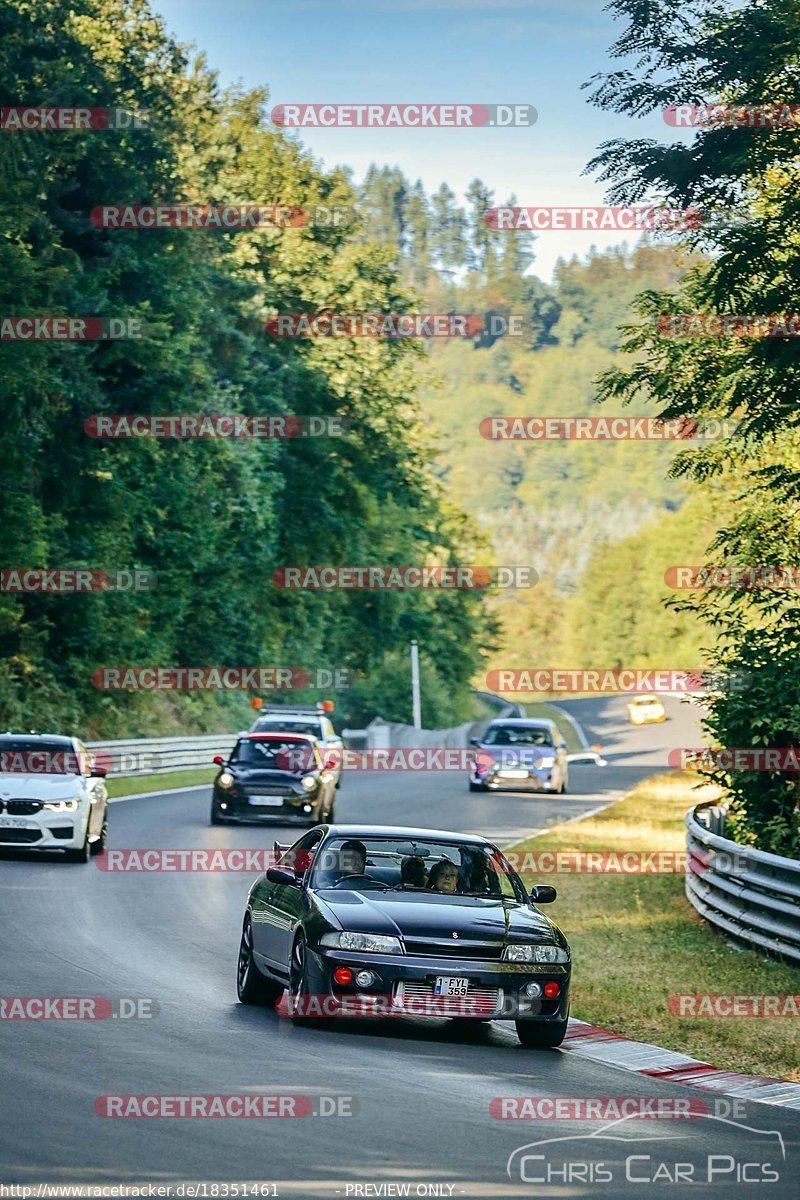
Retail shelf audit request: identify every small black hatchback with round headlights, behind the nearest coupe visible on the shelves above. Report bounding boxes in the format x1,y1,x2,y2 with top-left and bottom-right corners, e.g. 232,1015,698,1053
211,733,336,824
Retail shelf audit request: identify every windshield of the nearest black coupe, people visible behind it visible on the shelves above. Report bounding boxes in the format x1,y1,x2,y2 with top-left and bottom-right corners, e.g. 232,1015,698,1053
311,838,525,904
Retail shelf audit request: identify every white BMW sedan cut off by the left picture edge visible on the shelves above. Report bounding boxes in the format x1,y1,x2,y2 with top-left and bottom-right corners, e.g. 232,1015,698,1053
0,733,108,863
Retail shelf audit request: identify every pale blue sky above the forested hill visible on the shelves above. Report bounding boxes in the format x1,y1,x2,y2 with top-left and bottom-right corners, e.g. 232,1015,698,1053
151,0,674,278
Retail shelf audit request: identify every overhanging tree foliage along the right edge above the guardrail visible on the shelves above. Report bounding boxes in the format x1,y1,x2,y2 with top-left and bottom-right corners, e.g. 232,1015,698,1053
591,0,800,854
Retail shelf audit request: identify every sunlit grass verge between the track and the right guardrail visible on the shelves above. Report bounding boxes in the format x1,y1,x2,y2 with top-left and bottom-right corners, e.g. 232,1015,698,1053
510,773,800,1081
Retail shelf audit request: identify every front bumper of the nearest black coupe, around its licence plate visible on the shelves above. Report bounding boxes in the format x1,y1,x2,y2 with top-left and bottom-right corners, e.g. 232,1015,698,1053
304,947,572,1024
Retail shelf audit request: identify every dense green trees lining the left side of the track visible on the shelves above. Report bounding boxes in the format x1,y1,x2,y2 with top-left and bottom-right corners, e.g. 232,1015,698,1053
0,0,491,736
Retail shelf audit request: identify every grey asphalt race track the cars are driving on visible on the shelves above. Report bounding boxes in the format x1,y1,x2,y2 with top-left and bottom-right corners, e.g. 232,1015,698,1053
0,697,800,1200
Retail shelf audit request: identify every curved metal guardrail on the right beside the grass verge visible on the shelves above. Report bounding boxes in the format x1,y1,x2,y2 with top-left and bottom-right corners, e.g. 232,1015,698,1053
686,803,800,964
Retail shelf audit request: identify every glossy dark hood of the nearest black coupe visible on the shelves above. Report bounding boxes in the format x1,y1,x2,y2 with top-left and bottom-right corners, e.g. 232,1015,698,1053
317,888,559,943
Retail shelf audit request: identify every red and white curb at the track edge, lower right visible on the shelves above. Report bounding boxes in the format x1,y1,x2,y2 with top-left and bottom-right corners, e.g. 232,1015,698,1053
561,1018,800,1110
